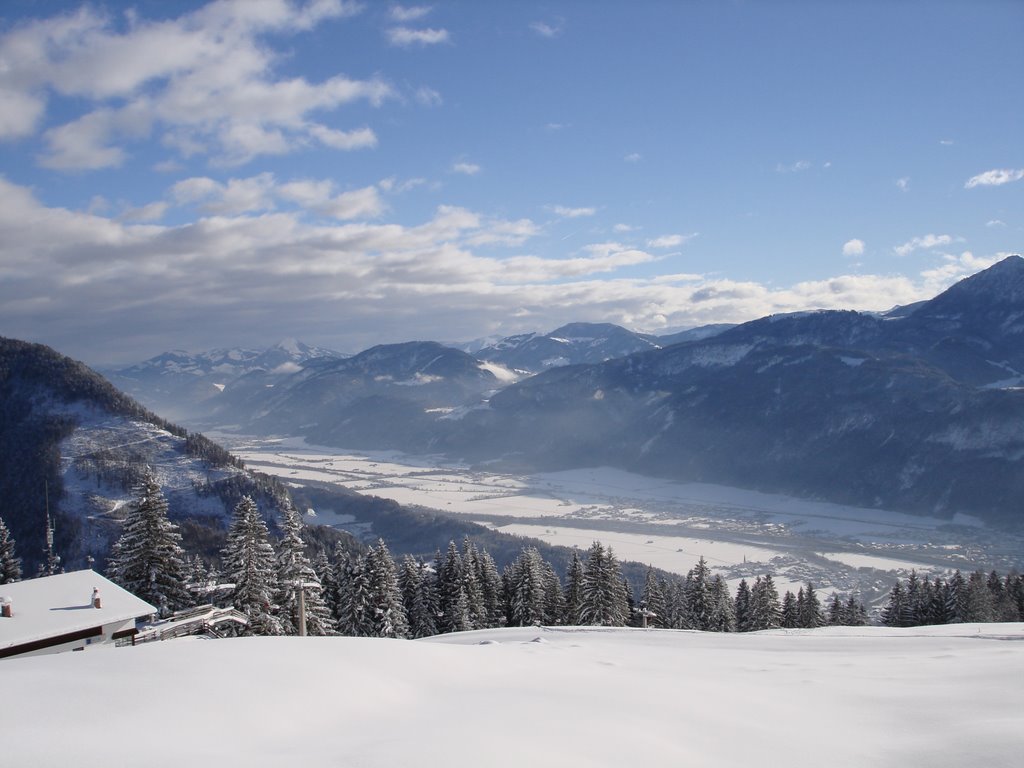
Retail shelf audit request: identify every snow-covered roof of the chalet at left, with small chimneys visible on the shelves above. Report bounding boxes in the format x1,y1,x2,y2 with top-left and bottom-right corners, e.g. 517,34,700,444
0,570,157,650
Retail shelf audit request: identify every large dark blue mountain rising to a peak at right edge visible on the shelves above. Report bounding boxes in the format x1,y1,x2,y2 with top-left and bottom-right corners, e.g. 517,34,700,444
435,256,1024,523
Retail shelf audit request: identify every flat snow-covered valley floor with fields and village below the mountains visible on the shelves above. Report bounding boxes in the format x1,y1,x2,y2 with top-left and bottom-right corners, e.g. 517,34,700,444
213,433,1024,601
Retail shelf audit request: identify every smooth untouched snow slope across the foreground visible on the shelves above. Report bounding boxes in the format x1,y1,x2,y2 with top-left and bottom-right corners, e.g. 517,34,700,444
0,624,1024,768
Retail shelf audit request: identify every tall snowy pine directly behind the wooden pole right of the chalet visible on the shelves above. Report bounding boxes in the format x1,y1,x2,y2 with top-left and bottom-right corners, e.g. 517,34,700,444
276,504,335,636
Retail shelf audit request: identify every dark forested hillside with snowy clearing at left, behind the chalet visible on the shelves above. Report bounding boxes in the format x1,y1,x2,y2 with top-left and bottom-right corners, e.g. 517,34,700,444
0,339,296,572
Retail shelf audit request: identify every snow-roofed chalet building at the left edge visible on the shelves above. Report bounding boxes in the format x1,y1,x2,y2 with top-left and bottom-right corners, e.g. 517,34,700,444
0,570,157,658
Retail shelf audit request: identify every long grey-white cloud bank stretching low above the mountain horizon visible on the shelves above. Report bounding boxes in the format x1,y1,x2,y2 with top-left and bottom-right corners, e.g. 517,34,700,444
0,174,1001,364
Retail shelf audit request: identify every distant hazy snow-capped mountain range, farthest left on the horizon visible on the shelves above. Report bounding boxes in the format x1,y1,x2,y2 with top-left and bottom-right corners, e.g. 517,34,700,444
100,339,345,420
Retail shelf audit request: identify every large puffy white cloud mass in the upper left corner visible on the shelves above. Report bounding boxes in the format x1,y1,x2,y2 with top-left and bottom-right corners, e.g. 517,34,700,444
0,0,385,170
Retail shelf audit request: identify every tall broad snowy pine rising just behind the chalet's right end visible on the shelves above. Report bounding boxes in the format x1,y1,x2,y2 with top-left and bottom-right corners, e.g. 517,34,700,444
106,475,193,616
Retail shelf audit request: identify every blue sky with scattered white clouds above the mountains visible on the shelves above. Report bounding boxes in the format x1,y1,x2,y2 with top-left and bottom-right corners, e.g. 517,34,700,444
0,0,1024,365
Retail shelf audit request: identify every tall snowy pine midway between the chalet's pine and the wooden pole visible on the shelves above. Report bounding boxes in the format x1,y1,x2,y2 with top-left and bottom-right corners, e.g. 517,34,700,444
221,496,282,635
